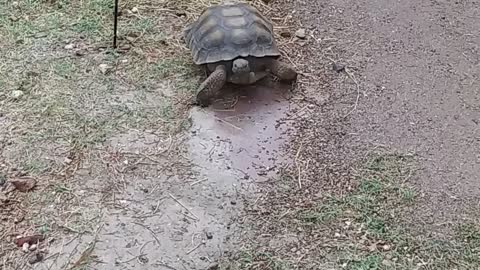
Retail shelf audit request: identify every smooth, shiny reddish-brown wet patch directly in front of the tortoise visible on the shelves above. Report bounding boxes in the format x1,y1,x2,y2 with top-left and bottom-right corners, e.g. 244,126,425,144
190,85,289,184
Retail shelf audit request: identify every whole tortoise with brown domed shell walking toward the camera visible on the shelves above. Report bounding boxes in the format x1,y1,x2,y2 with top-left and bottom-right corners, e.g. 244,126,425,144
184,1,297,106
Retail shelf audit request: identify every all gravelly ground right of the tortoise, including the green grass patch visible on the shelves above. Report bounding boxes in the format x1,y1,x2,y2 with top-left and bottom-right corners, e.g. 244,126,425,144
218,1,480,269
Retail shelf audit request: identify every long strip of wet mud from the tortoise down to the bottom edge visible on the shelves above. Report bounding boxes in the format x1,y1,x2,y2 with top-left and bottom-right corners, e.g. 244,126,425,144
178,86,289,269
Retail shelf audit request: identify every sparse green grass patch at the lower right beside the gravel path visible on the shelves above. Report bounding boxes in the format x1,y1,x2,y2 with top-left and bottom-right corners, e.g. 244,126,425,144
298,155,480,270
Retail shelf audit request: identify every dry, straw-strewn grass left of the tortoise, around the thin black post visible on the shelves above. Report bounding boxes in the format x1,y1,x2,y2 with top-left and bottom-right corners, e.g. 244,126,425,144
0,0,212,269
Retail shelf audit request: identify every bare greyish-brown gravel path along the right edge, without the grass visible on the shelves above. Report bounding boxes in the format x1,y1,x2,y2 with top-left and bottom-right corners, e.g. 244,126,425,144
297,1,480,232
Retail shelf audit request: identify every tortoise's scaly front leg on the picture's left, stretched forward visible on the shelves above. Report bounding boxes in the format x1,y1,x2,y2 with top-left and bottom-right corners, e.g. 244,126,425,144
197,65,227,107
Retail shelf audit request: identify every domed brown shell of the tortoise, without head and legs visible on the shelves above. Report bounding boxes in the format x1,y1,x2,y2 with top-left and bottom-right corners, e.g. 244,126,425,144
184,3,280,65
